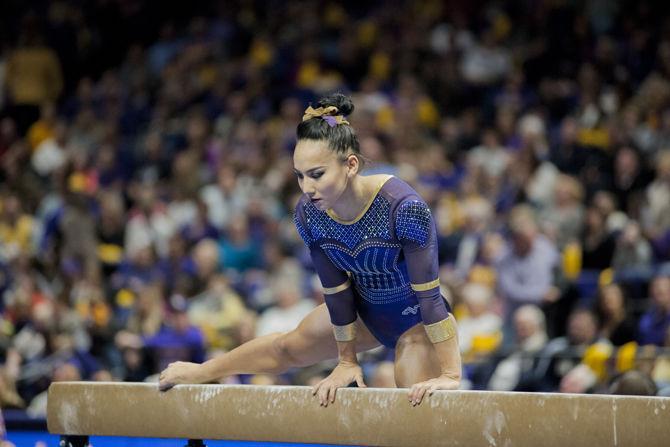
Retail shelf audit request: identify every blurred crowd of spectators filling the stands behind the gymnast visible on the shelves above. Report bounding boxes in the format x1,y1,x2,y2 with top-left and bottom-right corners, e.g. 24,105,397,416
0,0,670,415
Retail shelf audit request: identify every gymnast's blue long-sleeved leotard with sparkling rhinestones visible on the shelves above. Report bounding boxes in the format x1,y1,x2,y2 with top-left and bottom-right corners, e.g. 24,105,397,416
294,177,450,348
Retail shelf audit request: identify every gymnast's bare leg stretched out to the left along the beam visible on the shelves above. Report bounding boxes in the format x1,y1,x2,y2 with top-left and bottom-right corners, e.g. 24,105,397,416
159,304,380,390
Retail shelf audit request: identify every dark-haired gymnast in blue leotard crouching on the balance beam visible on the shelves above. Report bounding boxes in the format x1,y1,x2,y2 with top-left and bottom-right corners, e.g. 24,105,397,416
159,94,461,406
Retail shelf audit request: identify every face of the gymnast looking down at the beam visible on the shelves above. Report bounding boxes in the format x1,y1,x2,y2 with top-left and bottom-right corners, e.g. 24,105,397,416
293,140,358,211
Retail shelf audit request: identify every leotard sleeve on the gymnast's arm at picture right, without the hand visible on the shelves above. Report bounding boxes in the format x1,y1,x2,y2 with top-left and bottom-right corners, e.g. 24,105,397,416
394,196,450,325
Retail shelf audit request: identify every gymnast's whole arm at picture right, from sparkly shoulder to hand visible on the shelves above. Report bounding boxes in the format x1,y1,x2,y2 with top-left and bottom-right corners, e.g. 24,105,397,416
395,200,461,404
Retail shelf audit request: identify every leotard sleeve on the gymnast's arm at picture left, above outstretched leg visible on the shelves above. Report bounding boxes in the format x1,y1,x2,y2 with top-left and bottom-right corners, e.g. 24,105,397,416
293,201,356,326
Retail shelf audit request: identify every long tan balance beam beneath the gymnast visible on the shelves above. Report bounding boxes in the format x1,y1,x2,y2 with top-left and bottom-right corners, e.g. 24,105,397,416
47,382,670,447
